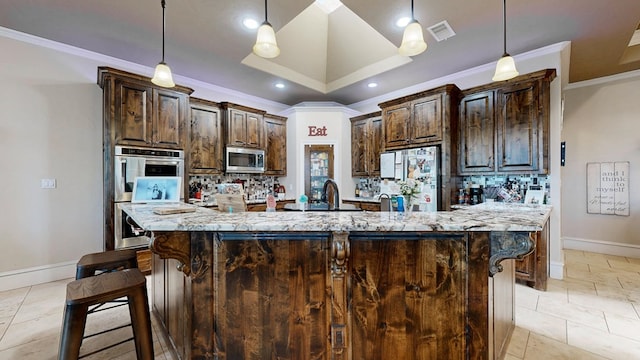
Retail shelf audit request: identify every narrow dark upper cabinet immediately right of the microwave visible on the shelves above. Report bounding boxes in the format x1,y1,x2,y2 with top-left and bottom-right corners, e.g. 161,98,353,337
264,114,287,176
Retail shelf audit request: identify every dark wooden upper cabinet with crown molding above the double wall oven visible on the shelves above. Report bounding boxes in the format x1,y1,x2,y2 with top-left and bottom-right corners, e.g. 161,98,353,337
98,67,193,149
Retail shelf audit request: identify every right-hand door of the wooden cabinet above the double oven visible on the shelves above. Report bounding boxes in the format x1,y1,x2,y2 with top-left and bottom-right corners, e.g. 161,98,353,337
153,90,186,148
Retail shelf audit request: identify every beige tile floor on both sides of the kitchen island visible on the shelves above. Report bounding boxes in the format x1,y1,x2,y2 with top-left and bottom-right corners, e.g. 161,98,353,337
0,250,640,360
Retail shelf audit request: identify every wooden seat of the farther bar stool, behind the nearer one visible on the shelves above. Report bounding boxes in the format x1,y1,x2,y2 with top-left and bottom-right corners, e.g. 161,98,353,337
76,249,138,280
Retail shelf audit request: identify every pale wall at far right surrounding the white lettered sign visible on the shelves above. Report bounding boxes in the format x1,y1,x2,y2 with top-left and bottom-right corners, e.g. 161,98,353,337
562,71,640,257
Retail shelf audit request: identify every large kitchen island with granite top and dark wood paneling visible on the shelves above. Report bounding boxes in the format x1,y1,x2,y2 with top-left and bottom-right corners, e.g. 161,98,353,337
124,204,551,360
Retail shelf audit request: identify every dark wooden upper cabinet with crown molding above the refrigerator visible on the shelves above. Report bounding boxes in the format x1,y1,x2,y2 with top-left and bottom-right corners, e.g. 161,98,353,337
379,85,457,150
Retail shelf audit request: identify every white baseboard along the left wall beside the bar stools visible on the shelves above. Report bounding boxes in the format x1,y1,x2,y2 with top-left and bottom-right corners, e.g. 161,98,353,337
0,261,76,291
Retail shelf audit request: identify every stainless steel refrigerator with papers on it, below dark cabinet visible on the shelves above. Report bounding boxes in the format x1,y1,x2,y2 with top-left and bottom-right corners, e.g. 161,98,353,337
380,146,440,211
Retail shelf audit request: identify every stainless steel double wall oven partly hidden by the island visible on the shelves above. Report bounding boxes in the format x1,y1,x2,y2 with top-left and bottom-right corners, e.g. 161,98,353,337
113,145,184,250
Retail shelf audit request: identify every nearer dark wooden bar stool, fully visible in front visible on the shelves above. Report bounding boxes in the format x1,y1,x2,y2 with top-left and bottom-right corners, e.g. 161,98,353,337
58,268,154,360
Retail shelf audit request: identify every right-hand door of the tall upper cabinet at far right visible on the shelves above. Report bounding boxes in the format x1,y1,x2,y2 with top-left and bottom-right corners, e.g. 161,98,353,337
496,82,541,171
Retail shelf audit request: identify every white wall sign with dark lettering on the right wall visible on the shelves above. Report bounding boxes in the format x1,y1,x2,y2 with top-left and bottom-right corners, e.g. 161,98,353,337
587,161,629,216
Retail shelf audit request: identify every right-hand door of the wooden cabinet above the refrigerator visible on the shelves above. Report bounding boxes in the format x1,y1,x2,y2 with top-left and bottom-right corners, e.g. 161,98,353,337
411,94,442,144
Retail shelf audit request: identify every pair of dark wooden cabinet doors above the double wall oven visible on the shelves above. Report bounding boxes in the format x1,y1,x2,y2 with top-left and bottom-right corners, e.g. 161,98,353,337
112,78,188,149
